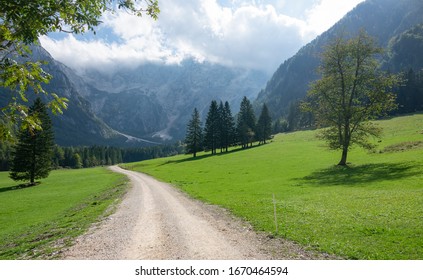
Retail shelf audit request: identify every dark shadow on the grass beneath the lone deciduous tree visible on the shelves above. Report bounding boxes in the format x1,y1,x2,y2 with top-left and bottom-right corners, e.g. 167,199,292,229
297,162,421,186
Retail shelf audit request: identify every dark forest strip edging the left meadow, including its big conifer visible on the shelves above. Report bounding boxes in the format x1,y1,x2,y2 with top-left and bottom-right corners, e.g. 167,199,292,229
0,98,183,179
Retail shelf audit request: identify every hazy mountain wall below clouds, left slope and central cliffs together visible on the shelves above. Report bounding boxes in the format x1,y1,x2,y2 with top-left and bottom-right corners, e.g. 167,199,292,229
0,46,268,146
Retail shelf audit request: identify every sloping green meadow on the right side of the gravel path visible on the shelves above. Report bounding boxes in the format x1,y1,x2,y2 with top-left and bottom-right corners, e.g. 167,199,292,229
125,114,423,259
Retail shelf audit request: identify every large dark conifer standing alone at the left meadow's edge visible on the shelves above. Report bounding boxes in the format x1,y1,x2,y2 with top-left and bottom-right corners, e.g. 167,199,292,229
10,98,54,185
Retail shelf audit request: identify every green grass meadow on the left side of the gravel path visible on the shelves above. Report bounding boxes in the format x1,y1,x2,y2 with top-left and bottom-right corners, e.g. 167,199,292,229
0,168,127,259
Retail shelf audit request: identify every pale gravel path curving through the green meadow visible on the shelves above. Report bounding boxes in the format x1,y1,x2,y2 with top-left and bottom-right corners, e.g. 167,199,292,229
61,166,329,260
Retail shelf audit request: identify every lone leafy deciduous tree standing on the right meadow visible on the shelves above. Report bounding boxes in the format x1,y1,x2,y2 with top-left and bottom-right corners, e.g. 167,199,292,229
305,31,399,165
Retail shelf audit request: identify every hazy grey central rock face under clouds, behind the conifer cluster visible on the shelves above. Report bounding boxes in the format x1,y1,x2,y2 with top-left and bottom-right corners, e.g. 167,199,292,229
81,60,268,142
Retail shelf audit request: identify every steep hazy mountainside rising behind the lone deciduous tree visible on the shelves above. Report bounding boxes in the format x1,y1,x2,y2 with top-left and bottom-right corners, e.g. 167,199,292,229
255,0,423,118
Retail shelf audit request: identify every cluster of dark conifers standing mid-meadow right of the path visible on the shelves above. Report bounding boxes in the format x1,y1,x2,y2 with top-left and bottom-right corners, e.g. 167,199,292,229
185,96,272,157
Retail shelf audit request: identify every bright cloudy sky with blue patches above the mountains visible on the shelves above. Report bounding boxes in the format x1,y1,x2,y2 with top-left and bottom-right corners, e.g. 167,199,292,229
40,0,363,74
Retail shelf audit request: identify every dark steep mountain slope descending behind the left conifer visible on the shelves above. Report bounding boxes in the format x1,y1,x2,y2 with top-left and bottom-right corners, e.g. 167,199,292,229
0,46,131,146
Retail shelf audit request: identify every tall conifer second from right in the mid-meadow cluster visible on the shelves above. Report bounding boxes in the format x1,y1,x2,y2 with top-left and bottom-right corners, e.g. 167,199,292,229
237,96,256,149
